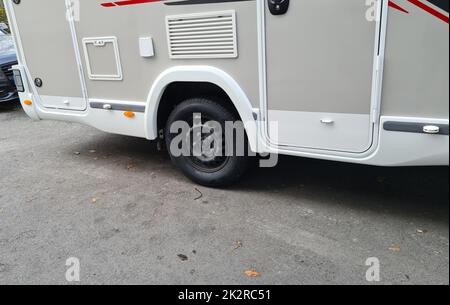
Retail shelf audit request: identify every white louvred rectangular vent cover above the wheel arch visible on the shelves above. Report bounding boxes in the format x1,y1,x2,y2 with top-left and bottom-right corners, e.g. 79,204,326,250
166,11,238,59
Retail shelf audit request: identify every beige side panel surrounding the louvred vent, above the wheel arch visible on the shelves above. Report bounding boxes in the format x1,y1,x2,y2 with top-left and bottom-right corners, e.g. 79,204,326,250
71,0,259,106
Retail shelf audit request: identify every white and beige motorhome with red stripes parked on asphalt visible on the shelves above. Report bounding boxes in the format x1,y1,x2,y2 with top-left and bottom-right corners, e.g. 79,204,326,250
5,0,449,186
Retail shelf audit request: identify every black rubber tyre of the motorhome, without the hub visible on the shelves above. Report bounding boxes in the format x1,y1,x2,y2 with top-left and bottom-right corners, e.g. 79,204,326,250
165,98,250,187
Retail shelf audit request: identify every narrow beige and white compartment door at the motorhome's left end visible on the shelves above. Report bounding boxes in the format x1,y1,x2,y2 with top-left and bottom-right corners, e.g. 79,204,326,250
8,0,87,111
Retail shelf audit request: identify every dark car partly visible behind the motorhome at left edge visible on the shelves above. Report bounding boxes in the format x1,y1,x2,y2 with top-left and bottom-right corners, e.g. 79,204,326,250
0,30,18,103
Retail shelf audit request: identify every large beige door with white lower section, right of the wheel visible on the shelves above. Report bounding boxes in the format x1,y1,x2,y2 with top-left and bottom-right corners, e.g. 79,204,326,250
264,0,377,153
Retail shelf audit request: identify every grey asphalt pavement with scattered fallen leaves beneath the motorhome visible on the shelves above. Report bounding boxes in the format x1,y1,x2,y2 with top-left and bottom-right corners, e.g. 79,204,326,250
0,101,449,285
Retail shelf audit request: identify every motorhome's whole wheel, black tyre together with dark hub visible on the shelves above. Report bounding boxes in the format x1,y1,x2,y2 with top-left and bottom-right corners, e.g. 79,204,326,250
165,98,250,187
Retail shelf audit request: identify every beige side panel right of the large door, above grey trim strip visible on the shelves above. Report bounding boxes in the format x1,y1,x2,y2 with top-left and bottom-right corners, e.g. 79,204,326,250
382,0,449,119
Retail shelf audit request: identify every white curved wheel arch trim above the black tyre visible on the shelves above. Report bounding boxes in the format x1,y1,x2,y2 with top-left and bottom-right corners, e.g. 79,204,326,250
145,66,258,151
